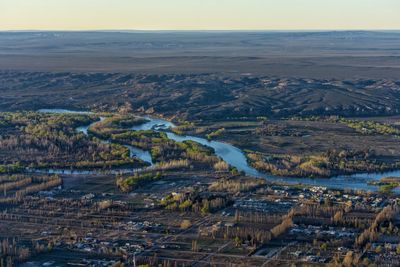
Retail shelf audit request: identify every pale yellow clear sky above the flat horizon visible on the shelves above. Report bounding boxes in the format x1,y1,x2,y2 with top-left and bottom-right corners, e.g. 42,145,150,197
0,0,400,30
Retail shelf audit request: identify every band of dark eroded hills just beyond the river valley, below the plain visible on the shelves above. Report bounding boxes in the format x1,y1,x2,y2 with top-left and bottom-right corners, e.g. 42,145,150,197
0,71,400,119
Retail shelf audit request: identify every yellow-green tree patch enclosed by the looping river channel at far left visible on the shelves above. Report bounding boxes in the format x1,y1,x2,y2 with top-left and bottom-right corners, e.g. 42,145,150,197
0,112,140,173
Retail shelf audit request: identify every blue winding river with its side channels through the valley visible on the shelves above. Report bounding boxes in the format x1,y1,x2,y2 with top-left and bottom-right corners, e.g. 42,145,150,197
39,109,400,193
